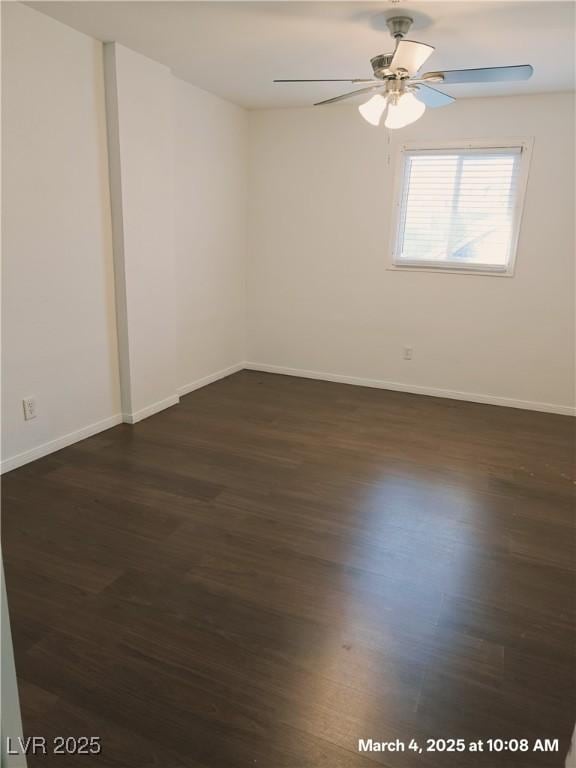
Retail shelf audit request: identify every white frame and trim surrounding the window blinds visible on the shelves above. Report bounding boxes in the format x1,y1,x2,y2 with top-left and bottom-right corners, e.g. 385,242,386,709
388,138,534,277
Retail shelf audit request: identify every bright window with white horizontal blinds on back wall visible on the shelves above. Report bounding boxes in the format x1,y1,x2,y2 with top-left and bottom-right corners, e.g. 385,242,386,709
393,143,529,274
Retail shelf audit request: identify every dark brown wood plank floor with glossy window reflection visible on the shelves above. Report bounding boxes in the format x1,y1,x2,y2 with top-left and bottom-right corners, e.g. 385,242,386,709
3,371,576,768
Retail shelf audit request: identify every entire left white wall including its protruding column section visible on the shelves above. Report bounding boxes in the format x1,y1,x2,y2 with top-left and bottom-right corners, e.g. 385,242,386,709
2,3,247,471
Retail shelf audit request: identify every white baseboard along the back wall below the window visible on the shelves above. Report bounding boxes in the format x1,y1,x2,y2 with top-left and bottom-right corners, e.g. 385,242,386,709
244,362,576,416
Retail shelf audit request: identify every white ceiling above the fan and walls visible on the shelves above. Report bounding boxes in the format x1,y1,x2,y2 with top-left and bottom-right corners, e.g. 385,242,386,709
27,0,575,108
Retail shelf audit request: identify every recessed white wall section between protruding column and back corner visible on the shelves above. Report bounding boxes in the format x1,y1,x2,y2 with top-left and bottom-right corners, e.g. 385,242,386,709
173,79,248,392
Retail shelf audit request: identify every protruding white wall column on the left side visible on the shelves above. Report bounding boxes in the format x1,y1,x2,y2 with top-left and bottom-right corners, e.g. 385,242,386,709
104,43,178,421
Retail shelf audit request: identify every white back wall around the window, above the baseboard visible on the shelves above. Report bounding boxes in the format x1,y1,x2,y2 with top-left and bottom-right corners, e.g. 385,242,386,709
248,94,574,410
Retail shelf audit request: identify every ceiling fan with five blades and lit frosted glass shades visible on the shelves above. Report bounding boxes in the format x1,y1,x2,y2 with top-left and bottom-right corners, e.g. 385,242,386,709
274,16,534,128
